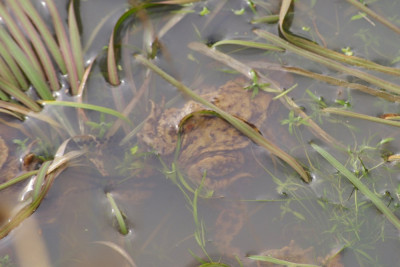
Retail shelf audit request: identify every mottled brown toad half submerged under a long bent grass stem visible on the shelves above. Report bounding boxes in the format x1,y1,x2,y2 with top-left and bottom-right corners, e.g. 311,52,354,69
138,78,272,190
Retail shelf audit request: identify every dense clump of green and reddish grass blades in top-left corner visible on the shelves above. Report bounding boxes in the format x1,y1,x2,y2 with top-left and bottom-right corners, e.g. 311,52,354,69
0,0,84,112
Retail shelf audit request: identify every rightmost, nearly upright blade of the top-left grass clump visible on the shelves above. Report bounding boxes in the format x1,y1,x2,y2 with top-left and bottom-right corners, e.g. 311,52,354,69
68,1,84,81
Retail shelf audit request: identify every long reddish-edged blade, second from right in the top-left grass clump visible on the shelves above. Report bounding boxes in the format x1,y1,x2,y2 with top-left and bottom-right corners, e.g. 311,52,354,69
43,0,79,95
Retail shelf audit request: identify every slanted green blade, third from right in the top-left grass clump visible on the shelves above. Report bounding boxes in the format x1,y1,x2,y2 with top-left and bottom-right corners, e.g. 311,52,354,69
14,0,67,74
